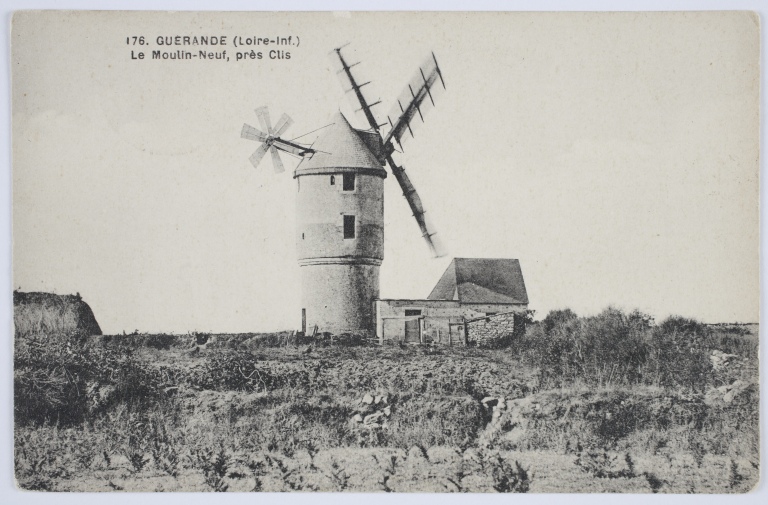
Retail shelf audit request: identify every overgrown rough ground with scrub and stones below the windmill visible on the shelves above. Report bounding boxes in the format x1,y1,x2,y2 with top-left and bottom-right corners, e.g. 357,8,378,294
14,302,759,493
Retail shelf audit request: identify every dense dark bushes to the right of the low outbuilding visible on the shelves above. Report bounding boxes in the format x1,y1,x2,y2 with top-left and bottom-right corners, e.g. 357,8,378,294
515,307,757,393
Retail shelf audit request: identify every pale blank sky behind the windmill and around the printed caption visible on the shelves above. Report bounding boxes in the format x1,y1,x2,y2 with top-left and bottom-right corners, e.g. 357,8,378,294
11,9,759,333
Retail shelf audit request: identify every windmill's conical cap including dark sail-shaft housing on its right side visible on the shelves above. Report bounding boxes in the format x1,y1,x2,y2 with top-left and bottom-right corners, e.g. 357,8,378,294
294,112,387,178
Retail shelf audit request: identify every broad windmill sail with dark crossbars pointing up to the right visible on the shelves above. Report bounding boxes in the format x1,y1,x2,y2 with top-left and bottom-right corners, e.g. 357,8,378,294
384,53,445,149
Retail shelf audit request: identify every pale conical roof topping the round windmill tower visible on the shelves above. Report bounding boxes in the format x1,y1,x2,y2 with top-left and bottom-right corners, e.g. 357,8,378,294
297,112,386,175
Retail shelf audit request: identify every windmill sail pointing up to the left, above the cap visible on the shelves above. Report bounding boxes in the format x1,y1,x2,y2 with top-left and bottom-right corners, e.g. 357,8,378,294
329,46,385,132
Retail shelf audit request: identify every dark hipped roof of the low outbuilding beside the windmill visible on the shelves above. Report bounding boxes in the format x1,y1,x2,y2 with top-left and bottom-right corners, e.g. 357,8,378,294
427,258,528,303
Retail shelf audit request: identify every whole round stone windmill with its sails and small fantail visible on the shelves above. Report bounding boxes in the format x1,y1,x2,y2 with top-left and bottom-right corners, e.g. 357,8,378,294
241,44,445,334
